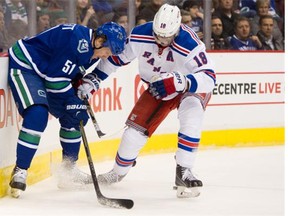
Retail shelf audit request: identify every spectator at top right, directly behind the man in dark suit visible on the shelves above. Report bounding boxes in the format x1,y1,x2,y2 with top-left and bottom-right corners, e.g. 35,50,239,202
251,0,283,44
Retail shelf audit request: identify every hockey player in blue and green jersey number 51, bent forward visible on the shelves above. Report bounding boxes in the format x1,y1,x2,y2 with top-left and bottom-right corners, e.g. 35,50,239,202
8,22,126,197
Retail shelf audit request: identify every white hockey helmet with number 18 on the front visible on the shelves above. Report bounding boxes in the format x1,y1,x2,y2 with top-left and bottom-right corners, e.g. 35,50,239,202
153,4,181,37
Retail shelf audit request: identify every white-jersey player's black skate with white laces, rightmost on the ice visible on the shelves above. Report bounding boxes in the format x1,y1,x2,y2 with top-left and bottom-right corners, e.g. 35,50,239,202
174,164,203,198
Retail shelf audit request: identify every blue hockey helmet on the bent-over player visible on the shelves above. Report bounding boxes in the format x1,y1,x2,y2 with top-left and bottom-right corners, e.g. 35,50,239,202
95,22,126,55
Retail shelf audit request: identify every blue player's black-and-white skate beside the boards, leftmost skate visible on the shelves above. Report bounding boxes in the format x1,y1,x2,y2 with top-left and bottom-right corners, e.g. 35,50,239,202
9,166,27,198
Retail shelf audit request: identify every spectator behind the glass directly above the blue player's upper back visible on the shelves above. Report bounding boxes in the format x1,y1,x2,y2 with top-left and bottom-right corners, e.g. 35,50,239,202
76,0,98,29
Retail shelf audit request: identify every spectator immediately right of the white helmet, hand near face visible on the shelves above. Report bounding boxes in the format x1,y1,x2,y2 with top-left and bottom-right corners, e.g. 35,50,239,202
183,0,204,40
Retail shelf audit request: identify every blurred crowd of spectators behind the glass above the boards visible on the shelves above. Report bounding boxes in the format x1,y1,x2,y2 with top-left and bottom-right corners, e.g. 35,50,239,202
0,0,284,52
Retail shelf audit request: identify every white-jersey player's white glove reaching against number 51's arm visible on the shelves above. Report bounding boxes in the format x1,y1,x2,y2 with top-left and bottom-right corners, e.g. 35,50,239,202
77,73,101,99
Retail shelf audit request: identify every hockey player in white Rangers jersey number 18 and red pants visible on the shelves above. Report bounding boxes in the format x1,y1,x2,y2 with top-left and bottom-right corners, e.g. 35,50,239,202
82,4,216,197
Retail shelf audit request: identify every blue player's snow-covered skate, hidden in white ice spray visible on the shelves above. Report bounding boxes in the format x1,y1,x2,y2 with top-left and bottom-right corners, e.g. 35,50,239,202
58,160,93,189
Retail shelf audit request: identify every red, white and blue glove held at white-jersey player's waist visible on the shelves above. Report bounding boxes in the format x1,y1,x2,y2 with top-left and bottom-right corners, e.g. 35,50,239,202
149,72,190,99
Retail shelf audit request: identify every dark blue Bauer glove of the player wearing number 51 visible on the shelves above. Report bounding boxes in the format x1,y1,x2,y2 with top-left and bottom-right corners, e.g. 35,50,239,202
60,96,89,130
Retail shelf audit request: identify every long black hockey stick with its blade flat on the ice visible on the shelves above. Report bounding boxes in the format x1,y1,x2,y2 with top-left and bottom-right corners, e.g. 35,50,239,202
80,120,134,209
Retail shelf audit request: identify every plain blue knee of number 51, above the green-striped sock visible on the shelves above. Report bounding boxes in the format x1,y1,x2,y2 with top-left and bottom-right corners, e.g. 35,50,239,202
22,105,49,132
